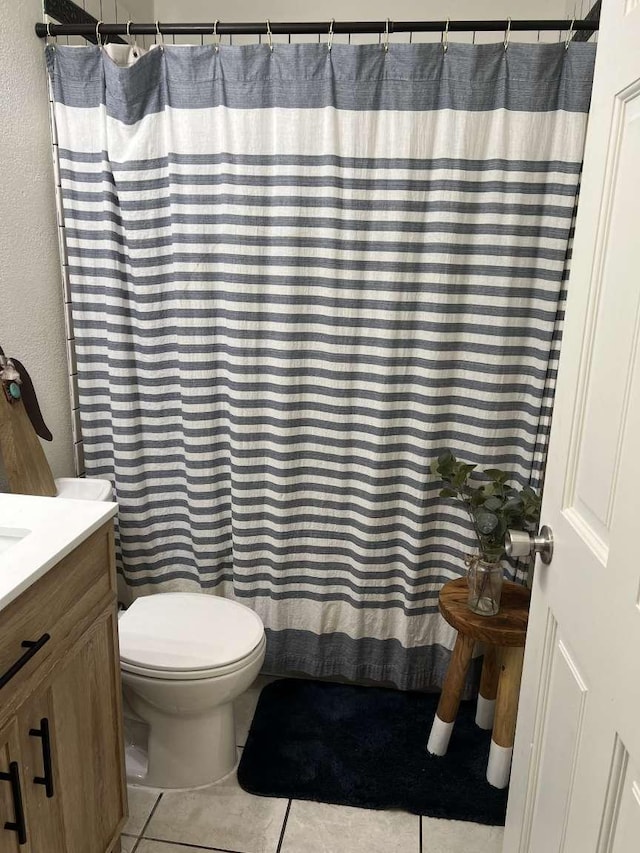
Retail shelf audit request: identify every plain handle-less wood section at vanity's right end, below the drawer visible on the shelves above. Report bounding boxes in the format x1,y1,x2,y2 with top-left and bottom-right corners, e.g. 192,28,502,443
51,606,126,853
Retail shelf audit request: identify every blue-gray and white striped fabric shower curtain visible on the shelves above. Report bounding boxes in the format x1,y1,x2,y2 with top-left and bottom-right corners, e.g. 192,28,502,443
47,43,595,688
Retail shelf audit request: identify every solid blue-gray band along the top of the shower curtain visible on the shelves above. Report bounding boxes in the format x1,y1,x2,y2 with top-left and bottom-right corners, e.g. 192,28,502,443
47,43,593,124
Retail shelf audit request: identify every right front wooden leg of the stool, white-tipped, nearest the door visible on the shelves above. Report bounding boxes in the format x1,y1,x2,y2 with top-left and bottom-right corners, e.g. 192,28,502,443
487,646,524,788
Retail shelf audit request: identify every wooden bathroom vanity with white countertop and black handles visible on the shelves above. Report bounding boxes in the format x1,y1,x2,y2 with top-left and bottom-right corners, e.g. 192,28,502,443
0,495,127,853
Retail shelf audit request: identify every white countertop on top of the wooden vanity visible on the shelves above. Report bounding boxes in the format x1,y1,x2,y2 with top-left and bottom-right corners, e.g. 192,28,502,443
0,494,118,610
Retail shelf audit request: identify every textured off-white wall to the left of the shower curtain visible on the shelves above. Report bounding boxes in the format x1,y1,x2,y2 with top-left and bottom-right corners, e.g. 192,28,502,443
0,0,73,476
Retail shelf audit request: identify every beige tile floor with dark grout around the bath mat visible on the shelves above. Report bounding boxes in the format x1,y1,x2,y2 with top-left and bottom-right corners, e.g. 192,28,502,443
122,678,503,853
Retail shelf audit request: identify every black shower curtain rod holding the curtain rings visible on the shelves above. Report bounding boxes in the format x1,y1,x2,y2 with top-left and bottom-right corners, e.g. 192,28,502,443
35,19,599,42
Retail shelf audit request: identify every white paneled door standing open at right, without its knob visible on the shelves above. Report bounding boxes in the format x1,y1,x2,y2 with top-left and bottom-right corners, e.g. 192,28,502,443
503,0,640,853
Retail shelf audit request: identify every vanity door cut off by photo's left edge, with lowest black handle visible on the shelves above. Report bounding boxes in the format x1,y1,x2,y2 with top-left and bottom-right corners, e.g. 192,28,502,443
0,721,31,853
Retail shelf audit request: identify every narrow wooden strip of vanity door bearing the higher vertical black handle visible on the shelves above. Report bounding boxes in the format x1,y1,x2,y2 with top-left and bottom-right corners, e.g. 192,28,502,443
18,687,65,853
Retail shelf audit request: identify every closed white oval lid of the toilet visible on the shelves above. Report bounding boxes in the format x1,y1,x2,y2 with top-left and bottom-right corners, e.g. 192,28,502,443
118,592,264,671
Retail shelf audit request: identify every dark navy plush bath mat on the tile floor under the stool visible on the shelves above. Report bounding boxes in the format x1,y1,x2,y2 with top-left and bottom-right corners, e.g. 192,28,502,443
238,679,507,826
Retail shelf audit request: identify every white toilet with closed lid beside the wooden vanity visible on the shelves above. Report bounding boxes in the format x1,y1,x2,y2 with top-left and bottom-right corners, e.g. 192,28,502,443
56,472,266,788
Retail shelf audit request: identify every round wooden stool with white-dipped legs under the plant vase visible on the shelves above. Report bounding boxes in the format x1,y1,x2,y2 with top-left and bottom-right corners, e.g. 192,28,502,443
427,578,530,788
